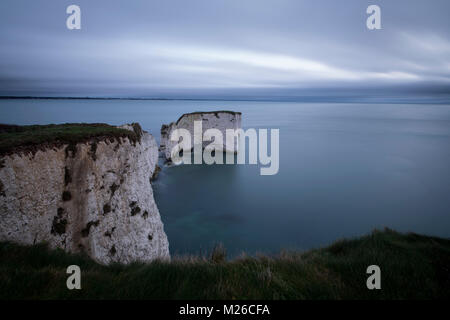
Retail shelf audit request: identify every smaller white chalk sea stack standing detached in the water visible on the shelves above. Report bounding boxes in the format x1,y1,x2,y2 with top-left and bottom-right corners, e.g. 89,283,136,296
160,111,242,160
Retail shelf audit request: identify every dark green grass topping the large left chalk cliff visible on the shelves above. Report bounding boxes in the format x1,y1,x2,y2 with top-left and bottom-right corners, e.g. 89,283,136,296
0,123,141,155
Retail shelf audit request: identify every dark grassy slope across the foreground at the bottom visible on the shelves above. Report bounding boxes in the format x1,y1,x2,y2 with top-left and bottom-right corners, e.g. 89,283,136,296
0,230,450,299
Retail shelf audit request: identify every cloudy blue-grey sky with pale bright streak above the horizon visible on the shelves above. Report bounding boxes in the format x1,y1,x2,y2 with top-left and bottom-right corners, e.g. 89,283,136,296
0,0,450,98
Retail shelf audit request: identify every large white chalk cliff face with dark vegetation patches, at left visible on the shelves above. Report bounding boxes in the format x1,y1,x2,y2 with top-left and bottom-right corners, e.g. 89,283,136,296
0,126,170,263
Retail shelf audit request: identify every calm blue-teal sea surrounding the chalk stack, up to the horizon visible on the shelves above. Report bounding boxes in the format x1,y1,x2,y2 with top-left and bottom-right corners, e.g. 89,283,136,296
0,100,450,255
